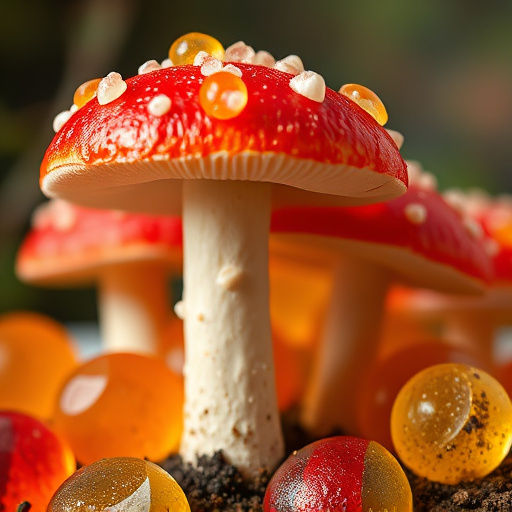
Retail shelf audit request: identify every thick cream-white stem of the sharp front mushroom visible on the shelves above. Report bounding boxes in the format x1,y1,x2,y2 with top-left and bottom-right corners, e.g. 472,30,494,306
180,180,284,478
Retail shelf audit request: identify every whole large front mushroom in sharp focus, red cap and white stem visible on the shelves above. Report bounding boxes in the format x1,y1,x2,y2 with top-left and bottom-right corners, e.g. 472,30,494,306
41,34,407,478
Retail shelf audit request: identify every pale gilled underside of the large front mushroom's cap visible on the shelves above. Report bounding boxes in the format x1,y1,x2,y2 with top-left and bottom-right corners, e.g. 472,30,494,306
41,151,406,215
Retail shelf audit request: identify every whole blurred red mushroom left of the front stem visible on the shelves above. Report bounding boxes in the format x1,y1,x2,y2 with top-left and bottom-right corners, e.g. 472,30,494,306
16,199,182,354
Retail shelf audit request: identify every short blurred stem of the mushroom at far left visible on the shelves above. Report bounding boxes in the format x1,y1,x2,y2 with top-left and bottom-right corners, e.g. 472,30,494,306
98,262,171,354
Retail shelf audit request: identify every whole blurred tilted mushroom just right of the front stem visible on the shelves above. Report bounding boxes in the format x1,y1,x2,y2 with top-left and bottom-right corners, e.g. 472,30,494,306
272,164,491,435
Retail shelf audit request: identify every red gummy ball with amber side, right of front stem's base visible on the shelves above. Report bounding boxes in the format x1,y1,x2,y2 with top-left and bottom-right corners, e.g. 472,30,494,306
264,436,413,512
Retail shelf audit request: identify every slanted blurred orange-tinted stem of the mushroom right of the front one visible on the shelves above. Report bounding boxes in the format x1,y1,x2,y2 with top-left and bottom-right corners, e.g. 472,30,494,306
301,255,390,436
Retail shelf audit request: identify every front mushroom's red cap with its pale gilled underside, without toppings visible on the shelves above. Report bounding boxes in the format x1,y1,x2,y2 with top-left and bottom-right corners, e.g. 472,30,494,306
41,62,407,213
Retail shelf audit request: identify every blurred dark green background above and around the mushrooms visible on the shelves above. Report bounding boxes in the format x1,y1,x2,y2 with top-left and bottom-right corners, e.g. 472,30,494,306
0,0,512,322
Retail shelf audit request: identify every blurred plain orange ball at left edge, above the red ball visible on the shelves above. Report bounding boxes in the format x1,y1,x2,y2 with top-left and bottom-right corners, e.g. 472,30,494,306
0,311,78,420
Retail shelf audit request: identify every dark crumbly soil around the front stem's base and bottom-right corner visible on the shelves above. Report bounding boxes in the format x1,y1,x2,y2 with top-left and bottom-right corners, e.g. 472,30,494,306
163,412,512,512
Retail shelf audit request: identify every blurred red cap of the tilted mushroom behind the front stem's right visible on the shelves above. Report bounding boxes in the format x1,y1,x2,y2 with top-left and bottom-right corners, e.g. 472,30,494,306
271,184,492,293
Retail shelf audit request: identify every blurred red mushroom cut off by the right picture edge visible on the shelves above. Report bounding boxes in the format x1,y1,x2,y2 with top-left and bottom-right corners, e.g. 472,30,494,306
395,189,512,365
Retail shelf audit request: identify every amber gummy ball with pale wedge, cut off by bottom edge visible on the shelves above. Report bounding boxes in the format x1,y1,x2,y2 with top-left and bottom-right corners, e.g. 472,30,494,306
48,457,190,512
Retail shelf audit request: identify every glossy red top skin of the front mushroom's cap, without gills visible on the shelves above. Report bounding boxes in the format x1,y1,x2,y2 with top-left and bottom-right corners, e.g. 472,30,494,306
41,63,407,183
